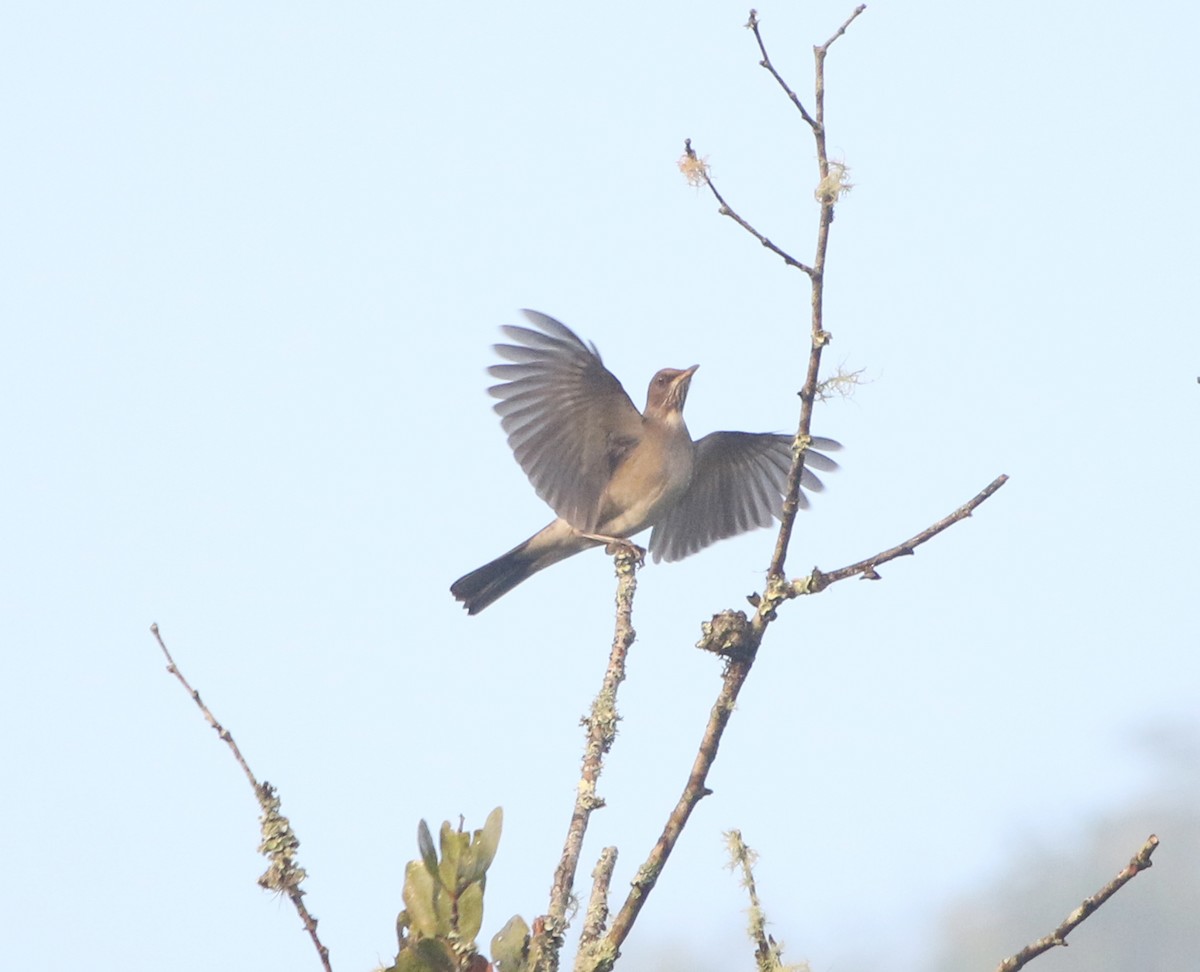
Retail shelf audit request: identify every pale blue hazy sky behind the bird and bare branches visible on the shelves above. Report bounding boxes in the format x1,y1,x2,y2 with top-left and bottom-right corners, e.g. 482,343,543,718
0,0,1200,972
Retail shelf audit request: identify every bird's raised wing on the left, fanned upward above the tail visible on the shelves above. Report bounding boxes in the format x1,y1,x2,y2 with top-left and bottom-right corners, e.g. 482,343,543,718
488,311,642,532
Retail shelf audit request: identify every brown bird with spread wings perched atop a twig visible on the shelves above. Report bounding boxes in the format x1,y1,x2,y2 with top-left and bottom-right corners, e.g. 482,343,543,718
450,311,841,614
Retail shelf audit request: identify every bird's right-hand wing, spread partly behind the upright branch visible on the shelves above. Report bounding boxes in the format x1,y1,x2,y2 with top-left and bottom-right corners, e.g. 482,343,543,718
650,432,841,560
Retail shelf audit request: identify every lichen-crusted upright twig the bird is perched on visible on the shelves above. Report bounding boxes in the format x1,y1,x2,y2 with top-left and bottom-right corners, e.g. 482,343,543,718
540,544,643,972
